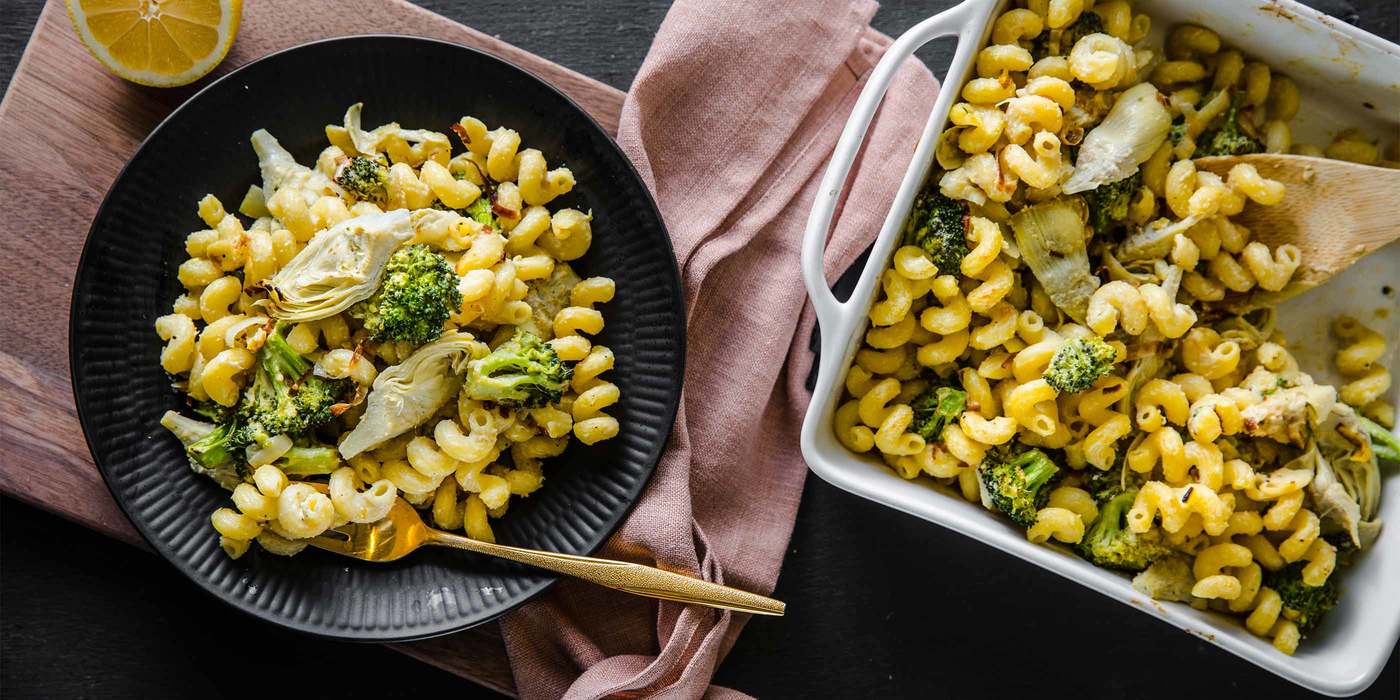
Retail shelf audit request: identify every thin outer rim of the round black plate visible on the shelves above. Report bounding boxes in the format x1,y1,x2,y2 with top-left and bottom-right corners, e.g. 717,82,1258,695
67,32,687,644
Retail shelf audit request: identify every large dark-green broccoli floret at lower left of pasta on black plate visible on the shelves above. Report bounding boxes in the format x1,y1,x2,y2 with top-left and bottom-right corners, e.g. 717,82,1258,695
238,323,350,441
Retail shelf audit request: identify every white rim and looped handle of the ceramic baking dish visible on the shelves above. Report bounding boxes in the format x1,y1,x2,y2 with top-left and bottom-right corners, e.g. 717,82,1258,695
801,0,1400,697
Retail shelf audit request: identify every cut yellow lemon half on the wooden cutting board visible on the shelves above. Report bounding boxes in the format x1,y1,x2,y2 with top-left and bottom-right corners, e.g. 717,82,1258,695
66,0,244,87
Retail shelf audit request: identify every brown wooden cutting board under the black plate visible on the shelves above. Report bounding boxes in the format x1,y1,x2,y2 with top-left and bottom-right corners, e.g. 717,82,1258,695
0,0,623,693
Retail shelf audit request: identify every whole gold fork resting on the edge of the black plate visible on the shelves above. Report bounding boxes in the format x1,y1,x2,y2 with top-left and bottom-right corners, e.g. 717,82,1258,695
307,484,784,615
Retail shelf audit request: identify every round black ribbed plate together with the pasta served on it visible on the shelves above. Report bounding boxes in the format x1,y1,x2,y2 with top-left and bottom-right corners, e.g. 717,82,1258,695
70,36,685,641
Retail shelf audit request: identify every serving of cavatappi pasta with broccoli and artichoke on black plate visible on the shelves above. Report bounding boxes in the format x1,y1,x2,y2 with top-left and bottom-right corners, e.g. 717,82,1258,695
155,104,619,557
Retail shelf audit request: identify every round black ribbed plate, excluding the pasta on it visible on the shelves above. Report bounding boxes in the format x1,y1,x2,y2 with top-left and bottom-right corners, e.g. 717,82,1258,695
69,36,685,641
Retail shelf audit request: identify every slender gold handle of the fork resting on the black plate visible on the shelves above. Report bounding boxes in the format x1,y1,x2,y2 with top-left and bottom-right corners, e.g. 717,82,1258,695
428,531,785,615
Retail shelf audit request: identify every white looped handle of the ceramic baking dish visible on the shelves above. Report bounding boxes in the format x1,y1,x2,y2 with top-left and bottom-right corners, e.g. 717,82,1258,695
802,0,983,344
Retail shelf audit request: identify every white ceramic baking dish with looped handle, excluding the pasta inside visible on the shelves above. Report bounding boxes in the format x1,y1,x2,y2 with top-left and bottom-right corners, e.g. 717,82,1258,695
802,0,1400,696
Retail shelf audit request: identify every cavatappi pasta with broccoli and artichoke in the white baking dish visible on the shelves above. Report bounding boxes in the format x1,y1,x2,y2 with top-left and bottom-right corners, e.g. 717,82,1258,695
834,0,1394,654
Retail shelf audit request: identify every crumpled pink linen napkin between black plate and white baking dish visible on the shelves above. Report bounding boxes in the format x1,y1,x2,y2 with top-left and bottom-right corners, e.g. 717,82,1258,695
501,0,938,699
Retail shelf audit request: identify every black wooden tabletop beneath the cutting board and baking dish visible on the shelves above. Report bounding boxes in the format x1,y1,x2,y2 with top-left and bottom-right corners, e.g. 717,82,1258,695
0,0,1400,700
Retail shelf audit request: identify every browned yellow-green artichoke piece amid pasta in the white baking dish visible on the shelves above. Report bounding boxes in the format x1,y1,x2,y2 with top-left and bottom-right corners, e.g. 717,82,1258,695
1011,197,1099,323
